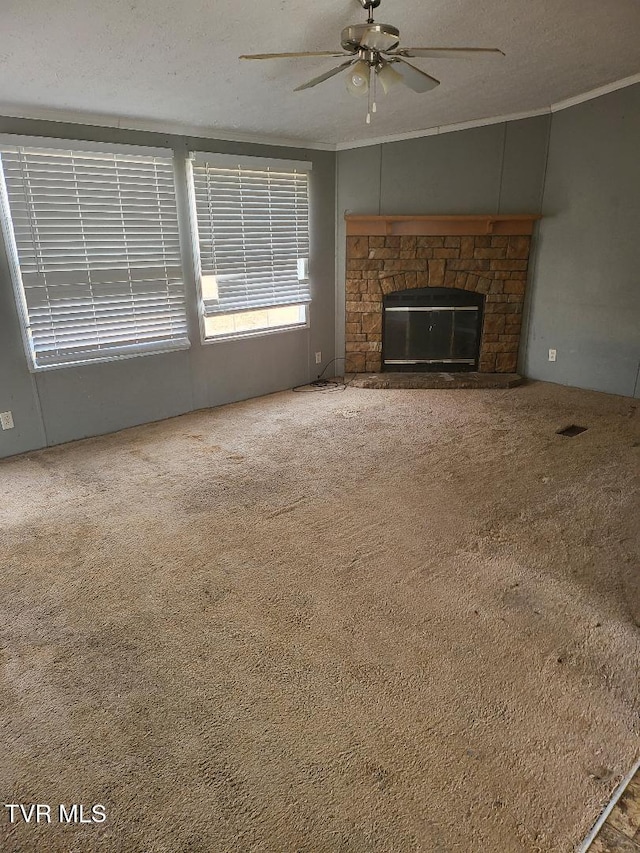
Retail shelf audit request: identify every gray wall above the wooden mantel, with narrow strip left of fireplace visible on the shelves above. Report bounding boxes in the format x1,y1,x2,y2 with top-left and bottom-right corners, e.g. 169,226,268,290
336,116,550,364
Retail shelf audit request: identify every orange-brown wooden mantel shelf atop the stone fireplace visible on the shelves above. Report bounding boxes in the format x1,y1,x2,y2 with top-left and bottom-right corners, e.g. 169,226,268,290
345,213,542,237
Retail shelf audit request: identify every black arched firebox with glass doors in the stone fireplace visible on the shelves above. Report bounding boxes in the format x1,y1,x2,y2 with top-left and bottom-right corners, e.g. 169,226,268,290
382,287,484,372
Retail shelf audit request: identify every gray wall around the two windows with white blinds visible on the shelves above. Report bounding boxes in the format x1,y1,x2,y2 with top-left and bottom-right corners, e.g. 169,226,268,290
0,118,335,457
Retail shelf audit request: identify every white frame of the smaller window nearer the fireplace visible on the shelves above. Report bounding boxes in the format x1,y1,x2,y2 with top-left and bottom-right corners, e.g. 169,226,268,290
187,149,313,346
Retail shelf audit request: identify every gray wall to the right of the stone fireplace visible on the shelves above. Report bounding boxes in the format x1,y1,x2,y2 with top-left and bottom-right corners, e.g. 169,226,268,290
524,85,640,397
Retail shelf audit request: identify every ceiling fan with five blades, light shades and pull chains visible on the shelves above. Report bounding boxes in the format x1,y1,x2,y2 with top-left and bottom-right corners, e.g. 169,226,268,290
240,0,505,124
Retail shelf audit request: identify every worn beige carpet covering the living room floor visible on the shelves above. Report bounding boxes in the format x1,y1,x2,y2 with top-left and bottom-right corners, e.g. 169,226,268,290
0,383,640,853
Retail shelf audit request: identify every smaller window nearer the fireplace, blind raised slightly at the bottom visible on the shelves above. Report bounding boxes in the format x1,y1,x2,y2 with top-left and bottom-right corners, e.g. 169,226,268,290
192,154,311,340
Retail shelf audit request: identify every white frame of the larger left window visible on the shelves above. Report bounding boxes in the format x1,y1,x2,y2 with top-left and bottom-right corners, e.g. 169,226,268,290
0,134,191,374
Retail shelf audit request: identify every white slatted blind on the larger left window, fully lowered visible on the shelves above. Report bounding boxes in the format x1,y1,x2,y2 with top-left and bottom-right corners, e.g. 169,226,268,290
0,147,189,367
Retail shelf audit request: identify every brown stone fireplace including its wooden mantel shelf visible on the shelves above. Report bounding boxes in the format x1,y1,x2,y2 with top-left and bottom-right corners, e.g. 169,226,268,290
345,215,539,373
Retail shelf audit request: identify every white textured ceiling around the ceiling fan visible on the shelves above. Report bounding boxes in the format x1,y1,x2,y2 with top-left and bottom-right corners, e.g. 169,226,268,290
0,0,640,146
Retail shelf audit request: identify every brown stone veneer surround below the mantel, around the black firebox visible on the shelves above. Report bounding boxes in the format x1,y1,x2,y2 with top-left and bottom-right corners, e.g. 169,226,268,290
345,217,534,373
